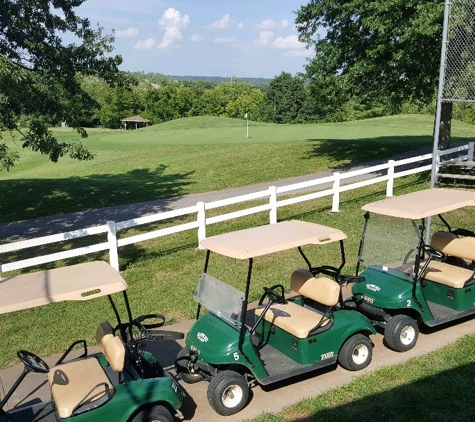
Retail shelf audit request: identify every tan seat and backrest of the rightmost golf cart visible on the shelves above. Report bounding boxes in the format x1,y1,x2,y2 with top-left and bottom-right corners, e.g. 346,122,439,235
424,232,475,289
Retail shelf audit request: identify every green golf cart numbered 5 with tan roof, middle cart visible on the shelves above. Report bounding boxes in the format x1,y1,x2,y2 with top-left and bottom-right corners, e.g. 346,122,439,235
176,221,376,416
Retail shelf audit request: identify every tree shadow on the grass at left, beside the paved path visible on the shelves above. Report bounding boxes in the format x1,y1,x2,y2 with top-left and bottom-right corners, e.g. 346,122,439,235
0,165,193,231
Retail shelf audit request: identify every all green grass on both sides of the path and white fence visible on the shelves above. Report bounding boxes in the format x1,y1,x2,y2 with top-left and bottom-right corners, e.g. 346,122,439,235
0,116,475,422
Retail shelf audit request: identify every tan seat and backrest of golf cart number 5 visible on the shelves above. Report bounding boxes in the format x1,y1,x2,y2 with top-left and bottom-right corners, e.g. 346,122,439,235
255,269,340,338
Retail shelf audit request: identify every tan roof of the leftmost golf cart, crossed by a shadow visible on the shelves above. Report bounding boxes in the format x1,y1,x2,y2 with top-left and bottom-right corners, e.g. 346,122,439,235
0,261,127,314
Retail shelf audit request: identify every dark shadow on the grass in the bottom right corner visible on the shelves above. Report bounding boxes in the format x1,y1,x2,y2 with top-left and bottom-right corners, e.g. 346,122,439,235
285,363,475,422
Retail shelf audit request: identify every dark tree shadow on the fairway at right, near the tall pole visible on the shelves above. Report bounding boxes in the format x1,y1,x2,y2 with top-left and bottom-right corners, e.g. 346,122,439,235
303,136,468,169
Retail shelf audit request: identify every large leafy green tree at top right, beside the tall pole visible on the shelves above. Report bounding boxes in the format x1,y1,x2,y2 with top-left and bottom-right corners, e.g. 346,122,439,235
296,0,444,112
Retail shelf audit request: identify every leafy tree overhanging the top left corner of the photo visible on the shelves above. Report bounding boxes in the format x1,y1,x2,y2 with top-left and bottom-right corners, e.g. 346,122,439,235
0,0,130,170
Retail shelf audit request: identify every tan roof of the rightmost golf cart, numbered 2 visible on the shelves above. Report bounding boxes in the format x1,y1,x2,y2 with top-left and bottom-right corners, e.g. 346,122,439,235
362,188,475,220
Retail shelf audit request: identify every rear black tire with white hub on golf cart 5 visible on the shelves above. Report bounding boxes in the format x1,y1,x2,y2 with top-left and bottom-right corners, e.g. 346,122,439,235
338,334,373,371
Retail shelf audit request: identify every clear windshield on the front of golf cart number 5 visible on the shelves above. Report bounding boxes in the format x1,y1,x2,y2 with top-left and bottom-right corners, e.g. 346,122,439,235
193,274,244,329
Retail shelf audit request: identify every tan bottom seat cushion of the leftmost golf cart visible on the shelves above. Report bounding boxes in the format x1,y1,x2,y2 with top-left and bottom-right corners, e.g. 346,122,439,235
48,357,114,418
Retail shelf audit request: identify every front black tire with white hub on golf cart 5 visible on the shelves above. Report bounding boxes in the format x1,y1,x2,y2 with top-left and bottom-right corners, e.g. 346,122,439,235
208,371,249,416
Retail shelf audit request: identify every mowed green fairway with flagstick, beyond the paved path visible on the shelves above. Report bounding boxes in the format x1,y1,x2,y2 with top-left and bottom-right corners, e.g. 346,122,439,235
0,115,475,222
